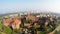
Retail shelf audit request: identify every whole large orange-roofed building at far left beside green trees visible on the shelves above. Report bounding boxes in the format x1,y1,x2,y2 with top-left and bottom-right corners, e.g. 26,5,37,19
3,17,21,29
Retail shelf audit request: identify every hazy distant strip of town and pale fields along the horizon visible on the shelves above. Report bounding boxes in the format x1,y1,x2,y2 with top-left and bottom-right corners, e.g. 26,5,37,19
0,12,60,19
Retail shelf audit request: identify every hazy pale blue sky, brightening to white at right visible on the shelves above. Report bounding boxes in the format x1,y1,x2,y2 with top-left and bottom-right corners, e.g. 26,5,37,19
0,0,60,13
